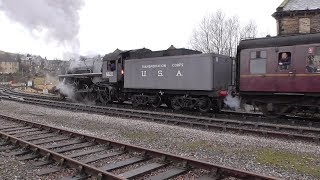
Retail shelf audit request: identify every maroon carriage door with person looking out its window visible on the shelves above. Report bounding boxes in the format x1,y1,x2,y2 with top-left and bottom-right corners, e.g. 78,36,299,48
274,47,296,93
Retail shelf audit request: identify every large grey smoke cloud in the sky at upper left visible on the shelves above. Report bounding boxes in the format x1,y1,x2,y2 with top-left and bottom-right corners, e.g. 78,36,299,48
0,0,84,57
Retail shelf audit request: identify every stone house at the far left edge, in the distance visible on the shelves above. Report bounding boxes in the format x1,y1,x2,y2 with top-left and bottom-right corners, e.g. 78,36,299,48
0,51,19,74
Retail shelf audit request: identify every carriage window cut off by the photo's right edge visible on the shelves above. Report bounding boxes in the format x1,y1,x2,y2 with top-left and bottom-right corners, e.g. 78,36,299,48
306,47,320,73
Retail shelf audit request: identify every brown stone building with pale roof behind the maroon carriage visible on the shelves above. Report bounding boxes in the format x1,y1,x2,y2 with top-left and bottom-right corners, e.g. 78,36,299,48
272,0,320,35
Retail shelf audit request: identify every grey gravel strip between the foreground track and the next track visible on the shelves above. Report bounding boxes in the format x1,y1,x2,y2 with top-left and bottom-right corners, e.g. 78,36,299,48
0,100,320,179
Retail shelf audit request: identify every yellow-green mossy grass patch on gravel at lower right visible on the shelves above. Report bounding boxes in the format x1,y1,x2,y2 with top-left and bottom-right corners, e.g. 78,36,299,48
255,149,320,178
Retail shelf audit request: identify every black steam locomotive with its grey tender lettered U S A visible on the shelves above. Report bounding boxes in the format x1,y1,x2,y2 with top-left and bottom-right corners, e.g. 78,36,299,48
59,48,232,112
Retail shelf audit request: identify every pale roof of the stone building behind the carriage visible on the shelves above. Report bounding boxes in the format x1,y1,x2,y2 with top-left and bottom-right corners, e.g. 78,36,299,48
277,0,320,11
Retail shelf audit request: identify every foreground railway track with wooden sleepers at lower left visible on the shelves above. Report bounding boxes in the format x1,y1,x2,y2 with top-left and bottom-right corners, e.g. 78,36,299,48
0,114,275,180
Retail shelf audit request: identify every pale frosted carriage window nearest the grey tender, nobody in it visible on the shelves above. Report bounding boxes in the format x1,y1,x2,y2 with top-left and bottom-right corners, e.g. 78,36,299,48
250,51,267,74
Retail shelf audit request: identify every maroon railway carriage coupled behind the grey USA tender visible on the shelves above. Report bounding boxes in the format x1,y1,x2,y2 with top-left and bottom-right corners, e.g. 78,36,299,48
236,33,320,115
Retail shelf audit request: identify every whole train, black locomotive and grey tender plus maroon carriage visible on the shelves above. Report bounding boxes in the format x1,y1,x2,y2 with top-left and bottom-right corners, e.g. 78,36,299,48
59,34,320,116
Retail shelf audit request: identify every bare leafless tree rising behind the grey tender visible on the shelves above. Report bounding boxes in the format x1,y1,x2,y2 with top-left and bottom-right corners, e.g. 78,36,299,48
190,10,257,56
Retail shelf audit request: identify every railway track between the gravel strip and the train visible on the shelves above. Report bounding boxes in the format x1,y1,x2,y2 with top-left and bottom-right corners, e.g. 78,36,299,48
3,88,320,144
